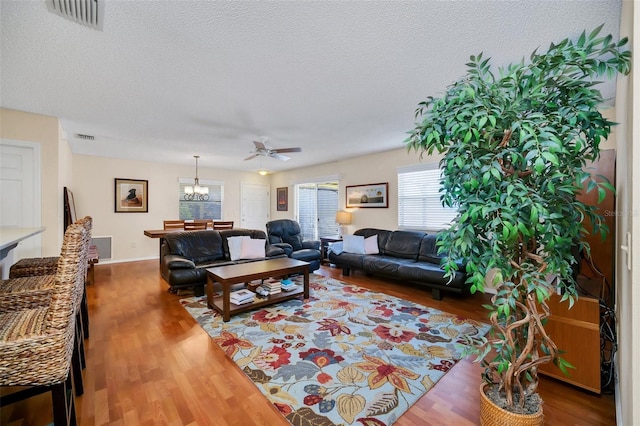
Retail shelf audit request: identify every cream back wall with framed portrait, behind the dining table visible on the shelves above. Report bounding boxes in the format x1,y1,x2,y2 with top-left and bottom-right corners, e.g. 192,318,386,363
68,155,273,261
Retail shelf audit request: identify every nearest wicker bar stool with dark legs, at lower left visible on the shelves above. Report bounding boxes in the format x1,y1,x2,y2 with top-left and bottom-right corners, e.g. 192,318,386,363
0,224,87,425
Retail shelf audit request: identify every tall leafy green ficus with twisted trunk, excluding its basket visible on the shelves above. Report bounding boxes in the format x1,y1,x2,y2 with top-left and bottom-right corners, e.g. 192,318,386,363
405,26,631,417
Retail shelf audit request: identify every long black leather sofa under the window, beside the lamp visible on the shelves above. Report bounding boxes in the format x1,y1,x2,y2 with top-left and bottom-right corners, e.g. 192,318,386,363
329,228,469,300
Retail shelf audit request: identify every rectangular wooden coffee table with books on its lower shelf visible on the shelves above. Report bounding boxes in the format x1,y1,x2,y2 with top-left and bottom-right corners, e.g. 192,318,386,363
207,257,309,322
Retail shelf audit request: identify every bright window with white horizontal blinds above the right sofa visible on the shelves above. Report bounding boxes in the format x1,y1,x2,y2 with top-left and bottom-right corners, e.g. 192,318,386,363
398,163,457,230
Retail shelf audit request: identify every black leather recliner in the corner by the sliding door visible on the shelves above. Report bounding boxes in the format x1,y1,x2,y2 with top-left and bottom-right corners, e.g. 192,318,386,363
267,219,322,272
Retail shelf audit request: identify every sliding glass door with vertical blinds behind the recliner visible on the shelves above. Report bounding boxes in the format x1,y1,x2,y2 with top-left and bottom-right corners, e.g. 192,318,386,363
296,182,338,240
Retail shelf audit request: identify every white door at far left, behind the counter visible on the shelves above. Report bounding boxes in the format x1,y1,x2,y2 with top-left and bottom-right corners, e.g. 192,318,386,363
0,139,42,261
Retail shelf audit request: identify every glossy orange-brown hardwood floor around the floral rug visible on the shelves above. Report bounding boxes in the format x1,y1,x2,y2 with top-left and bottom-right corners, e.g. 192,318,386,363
0,260,615,426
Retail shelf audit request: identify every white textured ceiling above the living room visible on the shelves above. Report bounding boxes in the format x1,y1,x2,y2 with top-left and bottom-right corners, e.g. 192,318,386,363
0,0,621,171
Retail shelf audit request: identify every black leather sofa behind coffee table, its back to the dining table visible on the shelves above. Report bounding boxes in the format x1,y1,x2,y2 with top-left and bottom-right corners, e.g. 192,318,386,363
160,228,286,296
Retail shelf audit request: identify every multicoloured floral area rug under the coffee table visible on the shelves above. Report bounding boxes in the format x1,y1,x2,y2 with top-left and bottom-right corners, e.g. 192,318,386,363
180,274,489,426
